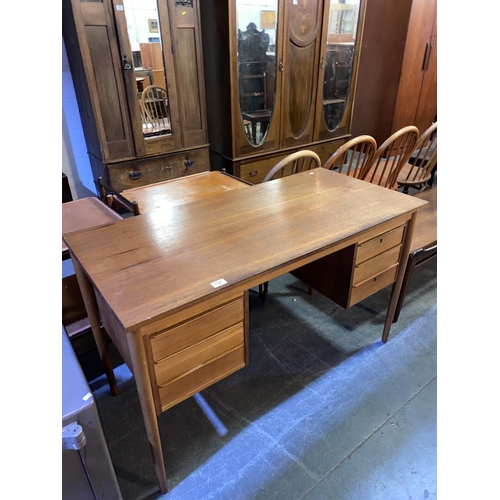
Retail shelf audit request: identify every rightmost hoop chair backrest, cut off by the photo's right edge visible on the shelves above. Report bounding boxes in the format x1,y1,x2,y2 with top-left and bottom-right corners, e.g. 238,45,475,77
398,122,437,184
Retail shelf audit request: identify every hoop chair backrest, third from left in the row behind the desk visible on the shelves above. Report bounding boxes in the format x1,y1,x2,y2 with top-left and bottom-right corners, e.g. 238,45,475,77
359,125,420,190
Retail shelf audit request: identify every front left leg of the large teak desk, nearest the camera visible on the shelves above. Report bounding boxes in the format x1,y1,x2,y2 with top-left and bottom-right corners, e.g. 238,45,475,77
127,332,168,493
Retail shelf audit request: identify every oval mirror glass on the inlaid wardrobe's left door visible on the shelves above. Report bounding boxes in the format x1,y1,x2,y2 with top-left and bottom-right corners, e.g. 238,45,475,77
236,0,278,146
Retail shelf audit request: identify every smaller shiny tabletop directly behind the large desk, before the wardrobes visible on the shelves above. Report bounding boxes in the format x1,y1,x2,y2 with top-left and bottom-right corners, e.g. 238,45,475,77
121,171,251,215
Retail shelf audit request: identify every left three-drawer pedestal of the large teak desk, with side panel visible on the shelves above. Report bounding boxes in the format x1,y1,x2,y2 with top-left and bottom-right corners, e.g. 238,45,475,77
96,291,249,415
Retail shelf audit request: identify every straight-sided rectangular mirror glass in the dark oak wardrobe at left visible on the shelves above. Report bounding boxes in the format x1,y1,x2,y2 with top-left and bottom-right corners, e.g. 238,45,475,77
122,0,172,139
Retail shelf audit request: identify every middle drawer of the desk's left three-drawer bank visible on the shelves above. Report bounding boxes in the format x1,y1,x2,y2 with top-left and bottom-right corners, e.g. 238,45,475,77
155,323,245,387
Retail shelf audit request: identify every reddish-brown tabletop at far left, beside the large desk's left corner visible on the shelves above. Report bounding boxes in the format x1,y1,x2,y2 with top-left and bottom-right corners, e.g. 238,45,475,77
62,197,121,252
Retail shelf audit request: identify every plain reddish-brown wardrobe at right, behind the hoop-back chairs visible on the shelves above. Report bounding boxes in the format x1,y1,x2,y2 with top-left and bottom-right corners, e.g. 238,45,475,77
352,0,437,144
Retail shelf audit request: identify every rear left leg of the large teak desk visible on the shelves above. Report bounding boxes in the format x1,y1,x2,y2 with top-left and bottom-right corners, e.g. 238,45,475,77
70,251,118,396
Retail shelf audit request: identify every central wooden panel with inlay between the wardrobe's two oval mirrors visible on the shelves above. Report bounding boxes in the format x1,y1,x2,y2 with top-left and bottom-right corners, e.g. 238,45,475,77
279,0,323,147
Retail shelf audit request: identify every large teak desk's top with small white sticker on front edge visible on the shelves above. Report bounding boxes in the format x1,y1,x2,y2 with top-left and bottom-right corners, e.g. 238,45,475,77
65,168,426,331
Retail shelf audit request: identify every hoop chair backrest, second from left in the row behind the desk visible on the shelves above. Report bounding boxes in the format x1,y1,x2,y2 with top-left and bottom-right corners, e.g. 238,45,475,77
323,135,377,178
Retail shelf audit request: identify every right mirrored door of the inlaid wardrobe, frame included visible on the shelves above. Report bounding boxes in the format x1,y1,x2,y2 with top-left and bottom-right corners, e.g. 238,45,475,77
315,0,366,141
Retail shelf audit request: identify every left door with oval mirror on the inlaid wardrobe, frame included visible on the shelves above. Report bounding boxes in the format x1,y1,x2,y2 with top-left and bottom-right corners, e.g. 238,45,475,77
232,0,283,156
